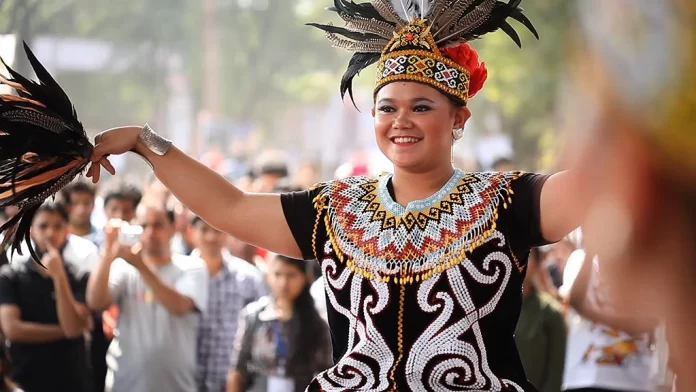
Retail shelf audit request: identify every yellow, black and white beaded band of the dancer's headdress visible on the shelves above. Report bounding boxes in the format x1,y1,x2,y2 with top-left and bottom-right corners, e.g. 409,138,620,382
375,20,469,102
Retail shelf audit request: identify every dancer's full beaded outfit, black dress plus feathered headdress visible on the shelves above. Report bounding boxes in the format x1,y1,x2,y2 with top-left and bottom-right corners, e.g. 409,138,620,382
282,0,547,391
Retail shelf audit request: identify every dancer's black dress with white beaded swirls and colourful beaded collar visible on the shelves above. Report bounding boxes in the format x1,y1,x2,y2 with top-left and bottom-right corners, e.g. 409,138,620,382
284,170,546,392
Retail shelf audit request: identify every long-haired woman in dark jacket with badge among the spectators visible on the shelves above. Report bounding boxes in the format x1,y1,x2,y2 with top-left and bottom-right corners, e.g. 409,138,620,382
227,255,331,392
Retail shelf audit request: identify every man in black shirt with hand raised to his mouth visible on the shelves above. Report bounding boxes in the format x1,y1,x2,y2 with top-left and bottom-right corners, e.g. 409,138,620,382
0,203,92,392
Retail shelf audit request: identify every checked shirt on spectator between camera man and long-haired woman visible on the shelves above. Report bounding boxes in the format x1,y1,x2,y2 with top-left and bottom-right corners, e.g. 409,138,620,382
193,250,266,392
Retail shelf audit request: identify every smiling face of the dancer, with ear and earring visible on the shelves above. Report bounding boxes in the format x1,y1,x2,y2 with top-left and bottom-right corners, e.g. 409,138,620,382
372,82,471,172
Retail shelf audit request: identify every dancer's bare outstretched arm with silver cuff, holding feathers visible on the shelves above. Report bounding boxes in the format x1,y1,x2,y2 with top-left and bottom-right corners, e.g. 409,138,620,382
87,127,302,259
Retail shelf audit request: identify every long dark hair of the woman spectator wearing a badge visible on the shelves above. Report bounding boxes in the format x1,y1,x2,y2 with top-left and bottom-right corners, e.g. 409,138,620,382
276,255,326,363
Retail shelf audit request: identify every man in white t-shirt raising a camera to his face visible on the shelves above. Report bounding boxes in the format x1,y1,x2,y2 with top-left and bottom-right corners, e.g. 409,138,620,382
87,204,209,392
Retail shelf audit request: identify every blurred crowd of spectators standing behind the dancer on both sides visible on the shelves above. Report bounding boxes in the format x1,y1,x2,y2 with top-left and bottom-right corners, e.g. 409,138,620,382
0,153,672,392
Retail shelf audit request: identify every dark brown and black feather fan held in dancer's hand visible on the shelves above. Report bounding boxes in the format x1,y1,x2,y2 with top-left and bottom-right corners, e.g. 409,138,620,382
0,44,94,263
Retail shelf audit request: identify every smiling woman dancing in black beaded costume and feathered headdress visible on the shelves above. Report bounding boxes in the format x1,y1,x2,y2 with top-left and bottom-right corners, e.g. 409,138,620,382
0,0,582,391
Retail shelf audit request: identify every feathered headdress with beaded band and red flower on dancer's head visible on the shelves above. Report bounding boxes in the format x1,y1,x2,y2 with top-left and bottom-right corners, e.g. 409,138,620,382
309,0,539,104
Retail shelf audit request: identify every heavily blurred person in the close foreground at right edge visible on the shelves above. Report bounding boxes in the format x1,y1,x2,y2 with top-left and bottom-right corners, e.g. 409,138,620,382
568,0,696,392
